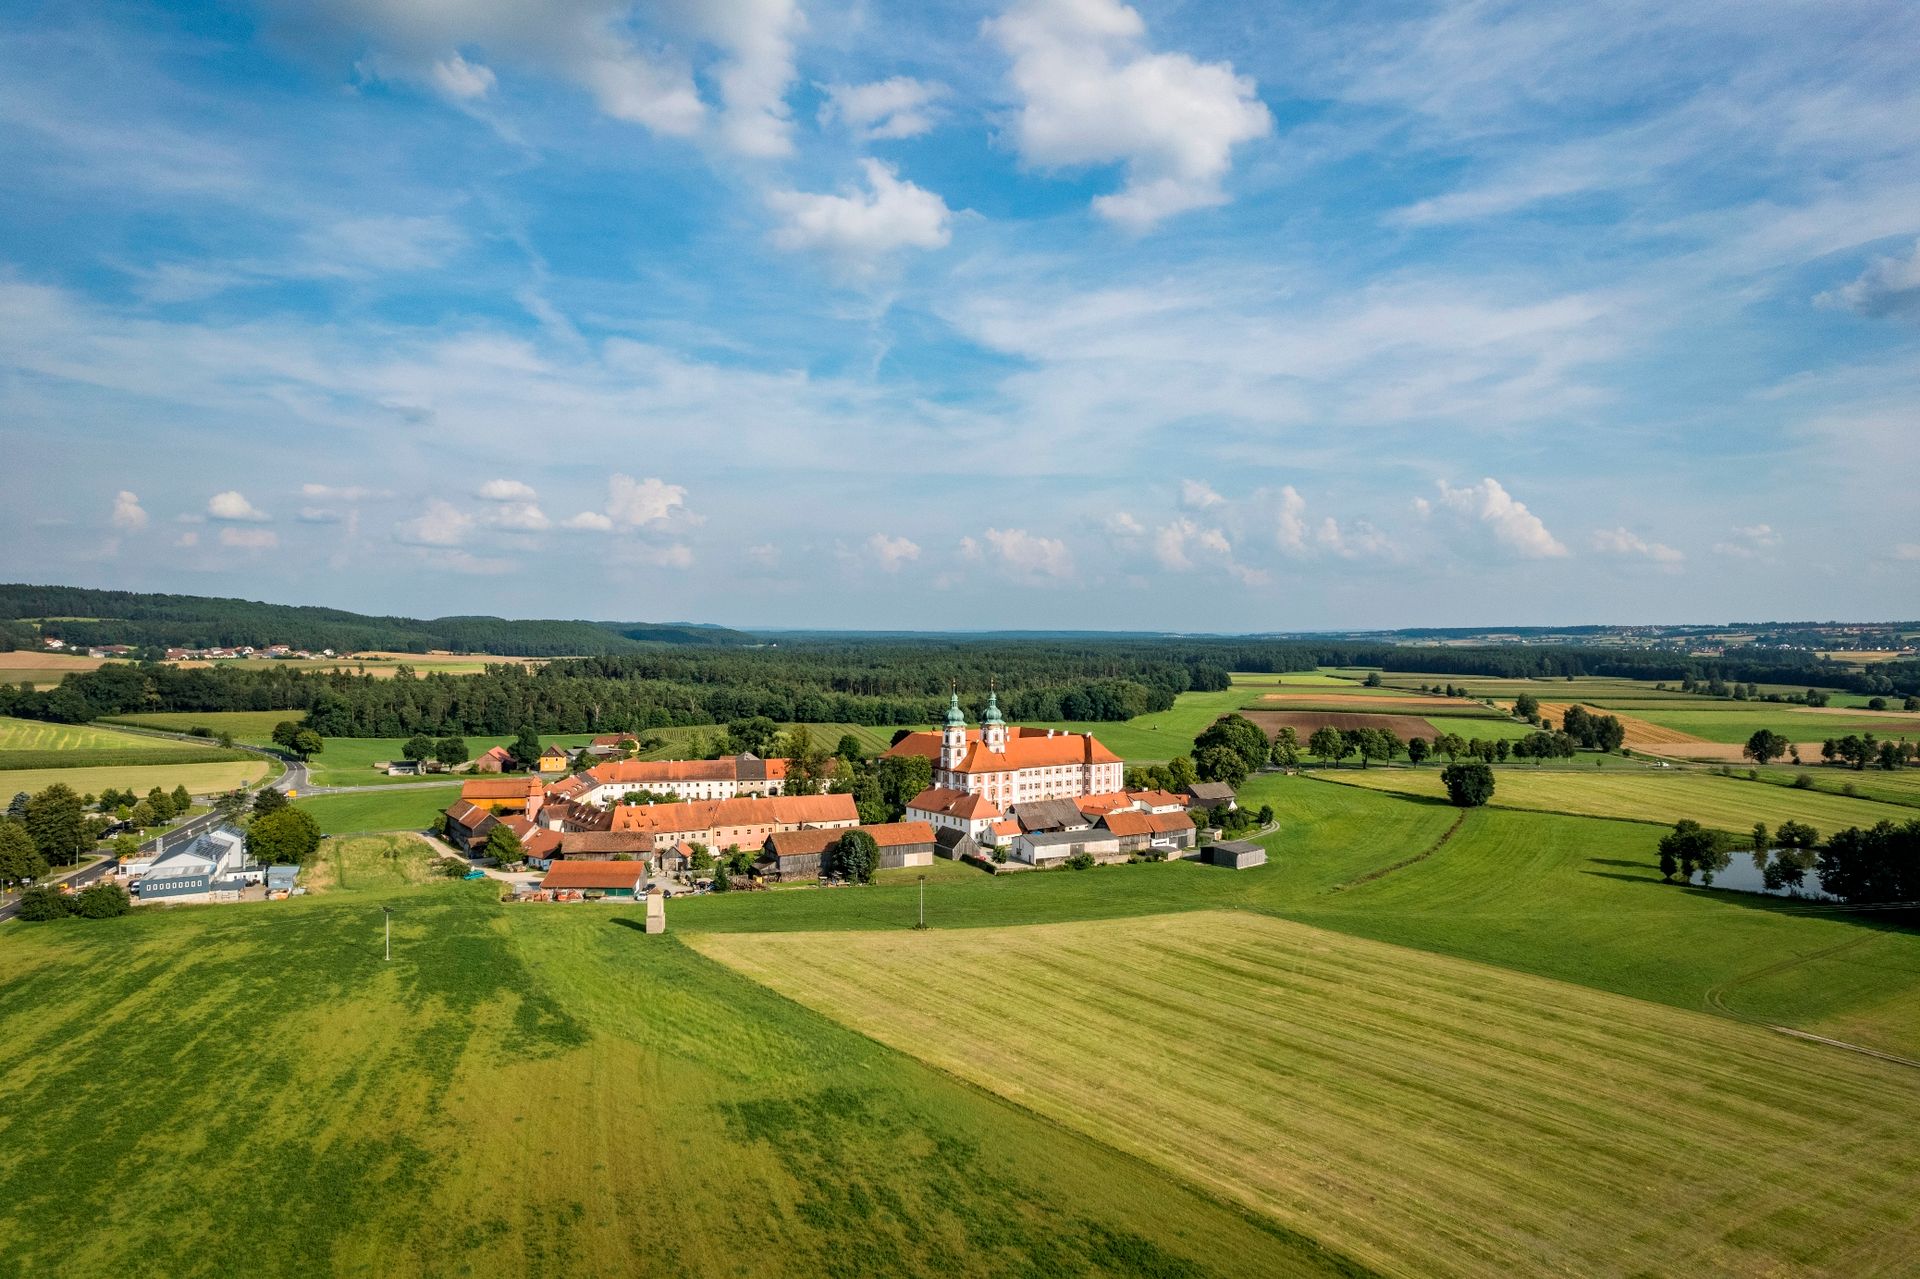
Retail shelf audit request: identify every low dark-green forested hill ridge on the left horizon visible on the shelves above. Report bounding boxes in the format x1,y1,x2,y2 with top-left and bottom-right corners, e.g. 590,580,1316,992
0,582,753,657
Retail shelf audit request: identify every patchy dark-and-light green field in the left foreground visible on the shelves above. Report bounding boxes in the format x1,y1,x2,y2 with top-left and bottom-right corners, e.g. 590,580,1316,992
0,845,1357,1279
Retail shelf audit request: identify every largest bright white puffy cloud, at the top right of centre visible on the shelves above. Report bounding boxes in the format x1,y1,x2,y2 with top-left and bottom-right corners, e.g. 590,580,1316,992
985,0,1273,230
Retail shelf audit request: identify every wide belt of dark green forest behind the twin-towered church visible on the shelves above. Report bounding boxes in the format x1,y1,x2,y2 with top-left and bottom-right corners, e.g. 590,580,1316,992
0,622,1920,737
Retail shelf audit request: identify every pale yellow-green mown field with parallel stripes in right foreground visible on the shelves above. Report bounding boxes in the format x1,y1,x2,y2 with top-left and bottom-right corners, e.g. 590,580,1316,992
693,912,1920,1275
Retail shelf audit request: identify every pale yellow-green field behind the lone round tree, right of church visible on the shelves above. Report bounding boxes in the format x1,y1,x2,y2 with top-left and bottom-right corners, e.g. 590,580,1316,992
1313,764,1910,835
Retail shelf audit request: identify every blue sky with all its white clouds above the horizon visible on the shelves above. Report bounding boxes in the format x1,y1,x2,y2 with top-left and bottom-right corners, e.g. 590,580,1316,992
0,0,1920,630
